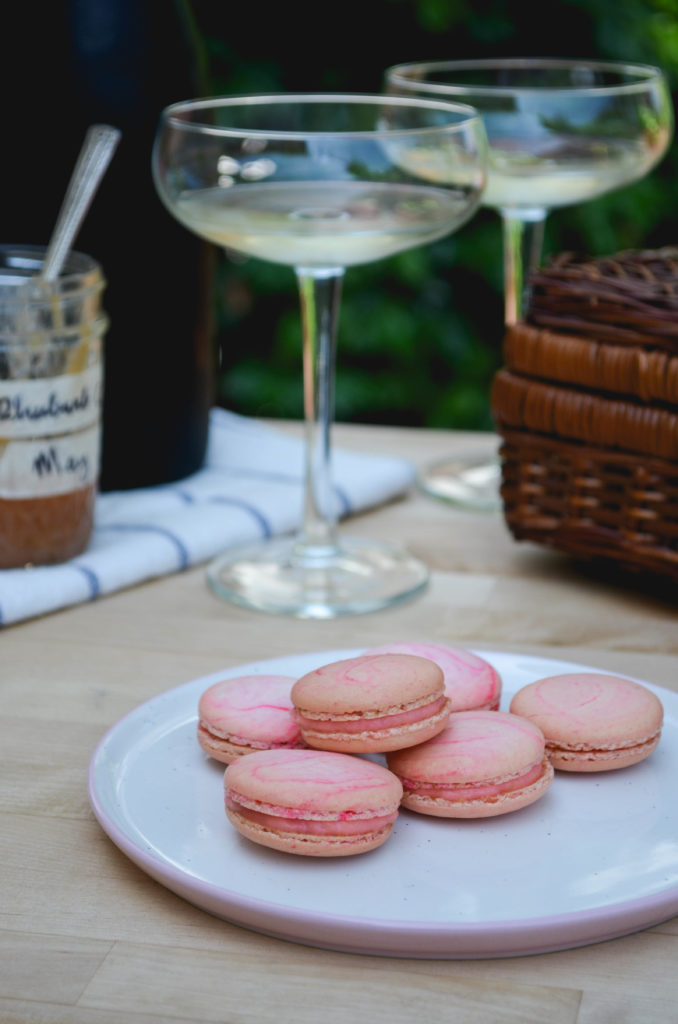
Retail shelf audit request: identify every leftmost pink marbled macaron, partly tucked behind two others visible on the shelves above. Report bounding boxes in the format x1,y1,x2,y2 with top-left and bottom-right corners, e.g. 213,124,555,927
198,675,306,764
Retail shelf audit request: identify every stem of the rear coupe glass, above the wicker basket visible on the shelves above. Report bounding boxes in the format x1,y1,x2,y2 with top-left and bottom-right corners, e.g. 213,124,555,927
501,207,546,327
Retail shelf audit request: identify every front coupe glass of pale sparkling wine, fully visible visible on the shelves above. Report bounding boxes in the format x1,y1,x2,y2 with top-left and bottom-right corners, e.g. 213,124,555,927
153,94,486,618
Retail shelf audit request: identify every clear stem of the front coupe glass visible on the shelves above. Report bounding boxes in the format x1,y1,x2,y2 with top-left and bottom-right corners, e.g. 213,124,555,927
295,267,344,563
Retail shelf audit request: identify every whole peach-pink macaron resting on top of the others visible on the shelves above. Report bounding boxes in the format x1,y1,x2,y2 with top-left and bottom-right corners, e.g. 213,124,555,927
292,654,450,754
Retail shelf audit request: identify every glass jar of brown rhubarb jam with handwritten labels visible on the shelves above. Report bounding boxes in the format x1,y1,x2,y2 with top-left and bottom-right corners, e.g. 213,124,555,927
0,246,108,568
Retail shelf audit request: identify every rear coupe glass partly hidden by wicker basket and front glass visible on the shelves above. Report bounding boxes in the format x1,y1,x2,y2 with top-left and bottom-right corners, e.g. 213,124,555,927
386,57,673,509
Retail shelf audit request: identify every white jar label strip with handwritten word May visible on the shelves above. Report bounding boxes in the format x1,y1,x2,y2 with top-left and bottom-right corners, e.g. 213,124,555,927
0,424,101,499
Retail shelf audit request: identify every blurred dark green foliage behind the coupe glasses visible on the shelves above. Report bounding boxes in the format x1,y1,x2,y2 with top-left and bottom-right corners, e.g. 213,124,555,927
192,0,678,429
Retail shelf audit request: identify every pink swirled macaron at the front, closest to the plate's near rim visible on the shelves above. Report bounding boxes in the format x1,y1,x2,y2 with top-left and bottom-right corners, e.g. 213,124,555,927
223,750,402,857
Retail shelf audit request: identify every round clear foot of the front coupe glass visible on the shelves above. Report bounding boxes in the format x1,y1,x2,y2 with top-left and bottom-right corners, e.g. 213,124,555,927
207,538,428,618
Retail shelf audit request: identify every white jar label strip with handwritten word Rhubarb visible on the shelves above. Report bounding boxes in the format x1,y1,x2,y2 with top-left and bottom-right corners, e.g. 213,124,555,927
0,364,102,439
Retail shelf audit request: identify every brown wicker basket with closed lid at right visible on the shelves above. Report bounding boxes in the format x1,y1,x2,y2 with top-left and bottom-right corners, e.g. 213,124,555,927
492,249,678,579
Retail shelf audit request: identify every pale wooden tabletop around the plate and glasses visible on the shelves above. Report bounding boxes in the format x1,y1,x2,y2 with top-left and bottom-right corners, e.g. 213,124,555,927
0,426,678,1024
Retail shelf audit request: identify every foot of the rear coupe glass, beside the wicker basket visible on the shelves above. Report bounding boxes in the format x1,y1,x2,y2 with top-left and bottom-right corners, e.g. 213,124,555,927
419,457,502,512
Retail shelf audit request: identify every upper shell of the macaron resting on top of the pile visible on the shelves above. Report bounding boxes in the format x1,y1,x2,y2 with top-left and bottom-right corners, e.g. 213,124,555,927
292,654,444,717
